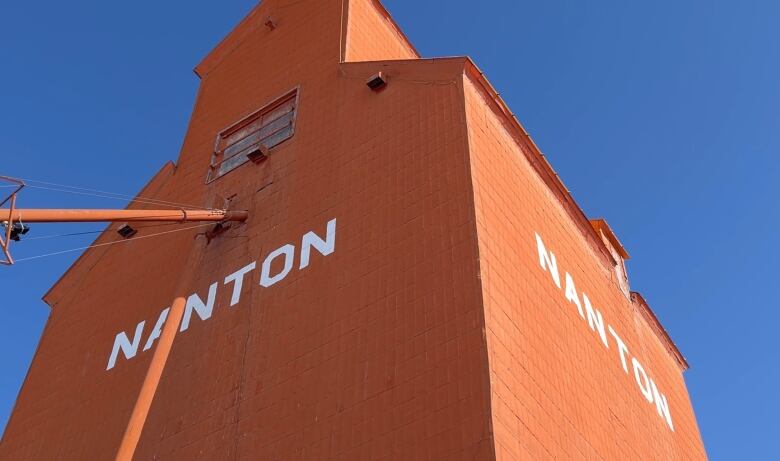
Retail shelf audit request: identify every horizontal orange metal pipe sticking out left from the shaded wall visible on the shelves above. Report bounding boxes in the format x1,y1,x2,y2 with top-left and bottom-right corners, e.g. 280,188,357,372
0,209,249,223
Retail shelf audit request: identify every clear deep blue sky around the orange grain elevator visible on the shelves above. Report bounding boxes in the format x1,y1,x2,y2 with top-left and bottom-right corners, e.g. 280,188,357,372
0,0,780,459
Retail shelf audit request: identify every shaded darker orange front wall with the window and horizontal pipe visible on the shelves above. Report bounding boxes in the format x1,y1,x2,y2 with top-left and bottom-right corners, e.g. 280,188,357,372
0,0,492,460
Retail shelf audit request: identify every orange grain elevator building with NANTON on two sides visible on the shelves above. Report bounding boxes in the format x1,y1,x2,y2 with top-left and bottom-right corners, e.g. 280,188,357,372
0,0,706,460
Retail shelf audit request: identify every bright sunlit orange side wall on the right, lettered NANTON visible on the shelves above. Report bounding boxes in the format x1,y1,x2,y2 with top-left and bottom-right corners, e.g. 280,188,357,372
465,73,706,459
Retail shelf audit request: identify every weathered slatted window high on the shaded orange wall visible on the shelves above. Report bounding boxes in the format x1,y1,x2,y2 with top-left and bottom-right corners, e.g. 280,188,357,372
206,90,298,182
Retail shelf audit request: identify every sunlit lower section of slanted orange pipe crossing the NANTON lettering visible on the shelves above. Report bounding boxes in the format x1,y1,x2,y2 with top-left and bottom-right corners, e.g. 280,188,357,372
115,297,186,461
